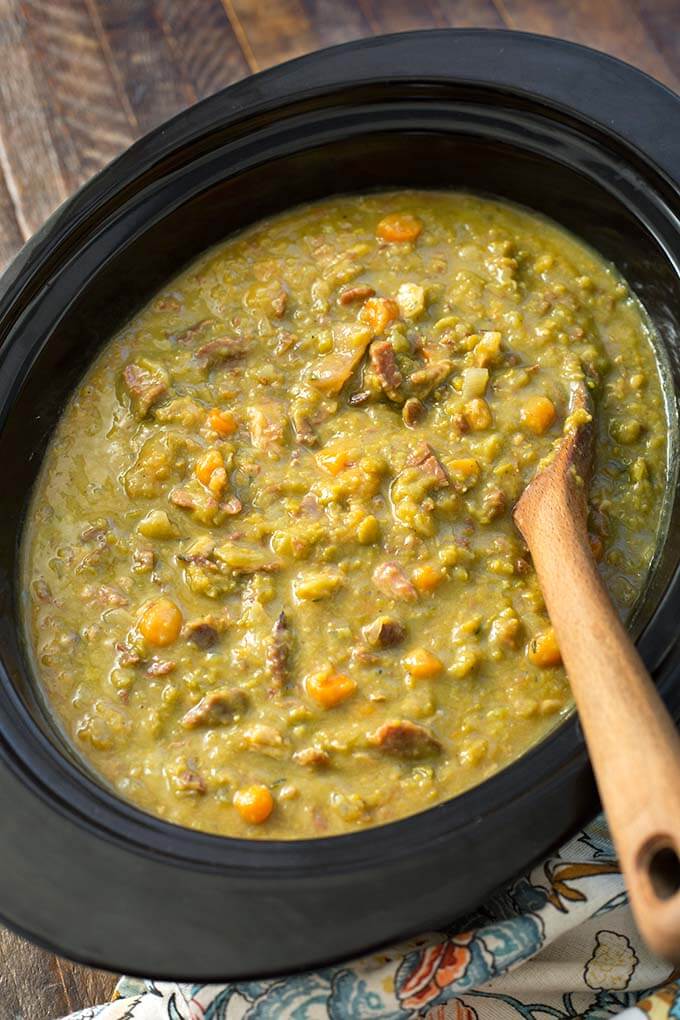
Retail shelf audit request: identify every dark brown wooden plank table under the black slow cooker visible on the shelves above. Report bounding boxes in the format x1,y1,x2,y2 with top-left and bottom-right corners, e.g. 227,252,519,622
0,0,680,1020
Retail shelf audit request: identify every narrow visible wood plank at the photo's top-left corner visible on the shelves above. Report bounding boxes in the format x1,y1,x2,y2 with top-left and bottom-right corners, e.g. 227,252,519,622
0,0,68,238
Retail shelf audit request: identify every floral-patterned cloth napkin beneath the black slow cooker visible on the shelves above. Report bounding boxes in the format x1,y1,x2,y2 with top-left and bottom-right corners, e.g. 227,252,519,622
61,816,680,1020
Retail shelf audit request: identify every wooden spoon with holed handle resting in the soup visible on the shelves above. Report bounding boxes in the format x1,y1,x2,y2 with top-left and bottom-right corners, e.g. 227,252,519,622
514,383,680,966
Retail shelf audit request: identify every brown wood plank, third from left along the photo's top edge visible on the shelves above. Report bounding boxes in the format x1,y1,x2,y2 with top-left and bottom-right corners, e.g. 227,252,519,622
89,0,196,132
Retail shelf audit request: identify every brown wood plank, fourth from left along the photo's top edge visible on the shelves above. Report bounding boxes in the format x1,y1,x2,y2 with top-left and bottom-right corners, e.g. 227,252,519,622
155,0,250,99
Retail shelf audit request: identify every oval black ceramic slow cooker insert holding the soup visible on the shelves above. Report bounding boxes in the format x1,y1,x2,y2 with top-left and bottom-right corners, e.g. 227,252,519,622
0,30,680,980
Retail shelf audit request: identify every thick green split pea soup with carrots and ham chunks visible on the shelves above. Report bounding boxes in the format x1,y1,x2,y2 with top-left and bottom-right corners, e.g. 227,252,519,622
24,192,666,838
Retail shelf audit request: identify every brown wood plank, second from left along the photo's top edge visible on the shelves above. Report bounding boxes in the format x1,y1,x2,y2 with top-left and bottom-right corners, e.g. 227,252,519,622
16,0,139,192
